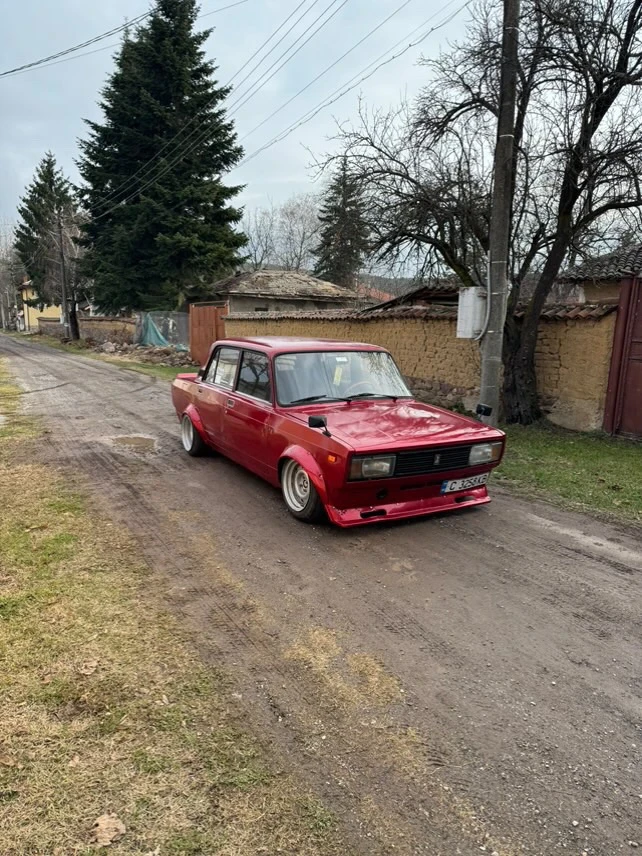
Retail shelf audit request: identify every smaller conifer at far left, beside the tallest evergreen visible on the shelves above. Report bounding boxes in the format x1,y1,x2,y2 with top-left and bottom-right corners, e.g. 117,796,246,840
15,152,74,305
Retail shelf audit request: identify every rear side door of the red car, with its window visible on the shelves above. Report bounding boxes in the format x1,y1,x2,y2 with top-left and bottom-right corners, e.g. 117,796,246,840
196,346,241,452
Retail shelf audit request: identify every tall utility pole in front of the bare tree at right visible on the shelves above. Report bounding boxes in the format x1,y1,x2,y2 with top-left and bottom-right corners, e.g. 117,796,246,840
480,0,520,425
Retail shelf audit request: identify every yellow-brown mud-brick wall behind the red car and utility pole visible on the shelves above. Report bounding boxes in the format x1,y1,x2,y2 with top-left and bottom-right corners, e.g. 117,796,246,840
225,313,615,431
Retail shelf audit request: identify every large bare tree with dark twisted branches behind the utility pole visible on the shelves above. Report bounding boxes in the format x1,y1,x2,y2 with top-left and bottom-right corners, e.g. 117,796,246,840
328,0,642,423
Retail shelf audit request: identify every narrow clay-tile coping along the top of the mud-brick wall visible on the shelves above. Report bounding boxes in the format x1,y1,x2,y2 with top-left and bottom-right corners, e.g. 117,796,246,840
227,302,617,324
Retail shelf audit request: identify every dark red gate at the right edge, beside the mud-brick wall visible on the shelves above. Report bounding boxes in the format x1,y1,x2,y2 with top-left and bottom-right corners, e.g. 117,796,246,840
604,279,642,439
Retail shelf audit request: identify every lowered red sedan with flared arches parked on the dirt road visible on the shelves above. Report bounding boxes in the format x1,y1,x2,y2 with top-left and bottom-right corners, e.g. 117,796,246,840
172,337,504,526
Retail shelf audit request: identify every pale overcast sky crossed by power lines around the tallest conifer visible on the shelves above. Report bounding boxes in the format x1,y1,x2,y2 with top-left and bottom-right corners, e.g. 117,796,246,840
0,0,467,223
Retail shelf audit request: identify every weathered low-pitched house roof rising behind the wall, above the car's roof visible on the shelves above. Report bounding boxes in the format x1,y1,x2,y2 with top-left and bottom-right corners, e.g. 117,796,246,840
212,270,355,303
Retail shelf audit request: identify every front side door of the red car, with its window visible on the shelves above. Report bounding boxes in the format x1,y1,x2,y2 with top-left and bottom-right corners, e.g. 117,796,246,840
225,350,276,481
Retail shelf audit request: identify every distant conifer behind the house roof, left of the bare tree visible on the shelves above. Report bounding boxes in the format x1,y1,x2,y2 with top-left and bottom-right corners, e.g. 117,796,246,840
314,158,369,290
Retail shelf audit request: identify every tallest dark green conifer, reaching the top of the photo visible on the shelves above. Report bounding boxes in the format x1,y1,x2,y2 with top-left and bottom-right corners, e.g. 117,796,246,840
78,0,246,312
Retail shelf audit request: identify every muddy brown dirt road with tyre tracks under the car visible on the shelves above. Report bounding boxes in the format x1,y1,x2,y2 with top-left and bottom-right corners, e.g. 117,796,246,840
0,336,642,856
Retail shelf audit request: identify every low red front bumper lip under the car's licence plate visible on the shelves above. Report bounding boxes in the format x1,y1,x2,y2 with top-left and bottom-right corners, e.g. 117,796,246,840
326,486,490,527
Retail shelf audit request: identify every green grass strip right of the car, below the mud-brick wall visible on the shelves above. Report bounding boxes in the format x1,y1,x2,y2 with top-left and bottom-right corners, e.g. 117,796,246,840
498,423,642,522
